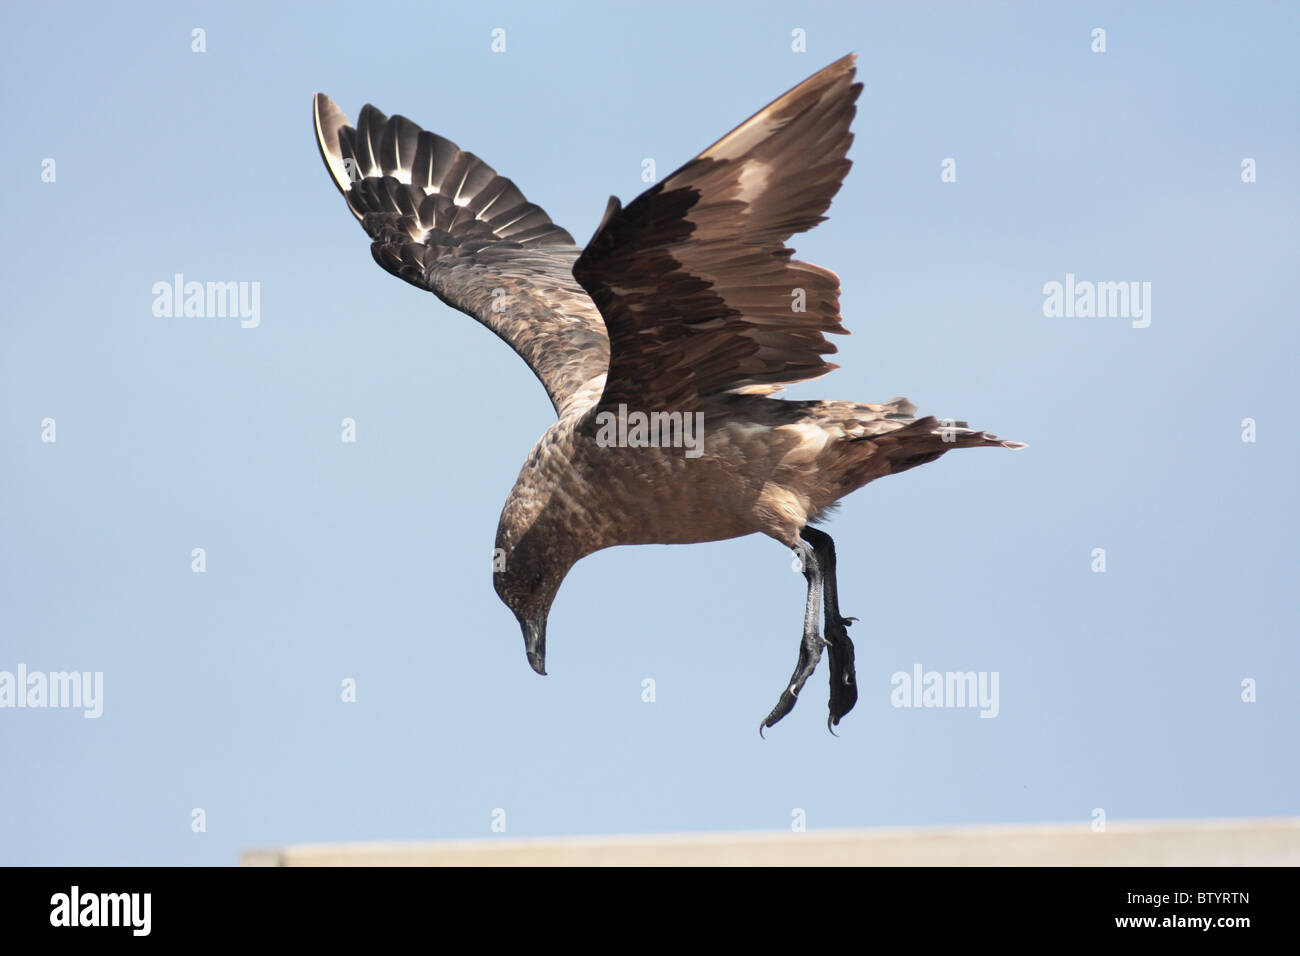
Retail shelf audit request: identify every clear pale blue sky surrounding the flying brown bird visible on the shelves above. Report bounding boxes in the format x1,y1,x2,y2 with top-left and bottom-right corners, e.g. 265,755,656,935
0,0,1300,864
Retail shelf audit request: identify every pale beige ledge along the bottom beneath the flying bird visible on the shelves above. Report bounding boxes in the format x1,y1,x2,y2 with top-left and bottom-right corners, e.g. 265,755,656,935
241,818,1300,866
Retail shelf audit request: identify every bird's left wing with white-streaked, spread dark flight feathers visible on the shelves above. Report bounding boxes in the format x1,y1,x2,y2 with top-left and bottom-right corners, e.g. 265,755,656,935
313,94,610,414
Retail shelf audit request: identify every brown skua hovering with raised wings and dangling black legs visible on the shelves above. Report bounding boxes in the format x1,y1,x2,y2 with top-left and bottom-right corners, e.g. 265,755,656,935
312,53,1023,735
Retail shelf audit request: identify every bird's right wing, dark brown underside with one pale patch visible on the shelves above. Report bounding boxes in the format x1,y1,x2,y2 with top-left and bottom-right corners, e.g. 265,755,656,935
573,55,862,410
